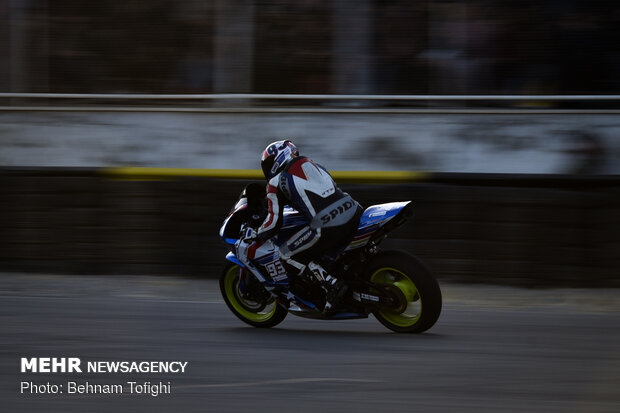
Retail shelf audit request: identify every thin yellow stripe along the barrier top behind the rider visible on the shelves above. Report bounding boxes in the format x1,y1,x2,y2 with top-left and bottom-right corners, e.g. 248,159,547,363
101,167,431,183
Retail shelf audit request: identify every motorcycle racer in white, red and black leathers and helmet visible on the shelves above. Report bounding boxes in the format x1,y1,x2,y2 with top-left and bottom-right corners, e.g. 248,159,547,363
235,140,363,313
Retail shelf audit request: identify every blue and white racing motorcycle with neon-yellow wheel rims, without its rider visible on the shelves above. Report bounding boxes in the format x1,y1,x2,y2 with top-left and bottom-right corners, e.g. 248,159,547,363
220,185,442,333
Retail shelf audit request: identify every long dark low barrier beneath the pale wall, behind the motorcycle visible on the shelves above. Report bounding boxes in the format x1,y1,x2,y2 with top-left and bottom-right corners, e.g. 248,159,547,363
0,169,620,286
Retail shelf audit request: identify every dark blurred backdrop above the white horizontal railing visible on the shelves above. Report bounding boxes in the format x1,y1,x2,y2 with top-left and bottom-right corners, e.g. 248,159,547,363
0,0,620,95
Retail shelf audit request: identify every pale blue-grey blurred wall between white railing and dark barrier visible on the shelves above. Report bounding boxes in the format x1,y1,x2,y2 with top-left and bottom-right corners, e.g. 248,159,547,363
0,112,620,174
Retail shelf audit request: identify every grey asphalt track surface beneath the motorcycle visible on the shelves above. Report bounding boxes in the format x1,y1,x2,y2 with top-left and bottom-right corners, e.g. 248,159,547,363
0,274,620,413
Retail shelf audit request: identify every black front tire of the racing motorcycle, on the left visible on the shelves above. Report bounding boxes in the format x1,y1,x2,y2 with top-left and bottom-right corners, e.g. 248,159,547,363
220,262,287,328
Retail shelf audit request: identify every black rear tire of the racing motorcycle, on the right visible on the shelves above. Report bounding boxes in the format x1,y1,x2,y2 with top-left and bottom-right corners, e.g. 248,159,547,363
364,251,442,333
